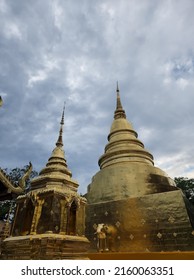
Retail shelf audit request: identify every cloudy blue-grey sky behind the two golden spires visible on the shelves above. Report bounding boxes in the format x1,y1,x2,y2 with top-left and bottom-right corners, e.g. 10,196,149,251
0,0,194,193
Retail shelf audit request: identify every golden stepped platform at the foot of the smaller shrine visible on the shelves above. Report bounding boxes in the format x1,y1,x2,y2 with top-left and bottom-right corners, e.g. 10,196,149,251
1,233,89,260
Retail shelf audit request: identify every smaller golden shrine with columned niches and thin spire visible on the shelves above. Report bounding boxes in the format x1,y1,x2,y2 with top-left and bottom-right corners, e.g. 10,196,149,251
2,106,89,260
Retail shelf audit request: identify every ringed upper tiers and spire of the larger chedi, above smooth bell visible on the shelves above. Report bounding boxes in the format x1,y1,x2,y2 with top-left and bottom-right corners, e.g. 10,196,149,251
99,88,153,169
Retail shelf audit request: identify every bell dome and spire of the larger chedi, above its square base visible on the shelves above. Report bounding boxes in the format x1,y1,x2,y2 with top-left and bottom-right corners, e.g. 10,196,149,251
87,86,176,203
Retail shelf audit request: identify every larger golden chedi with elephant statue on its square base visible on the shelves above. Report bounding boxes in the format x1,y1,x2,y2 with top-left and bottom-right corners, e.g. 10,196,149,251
86,86,194,252
